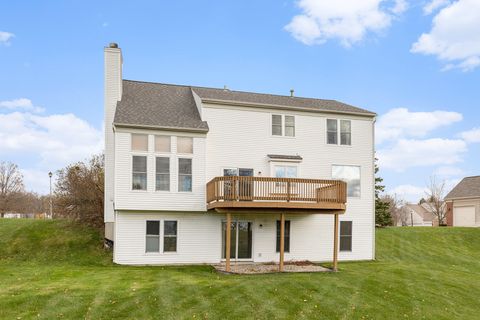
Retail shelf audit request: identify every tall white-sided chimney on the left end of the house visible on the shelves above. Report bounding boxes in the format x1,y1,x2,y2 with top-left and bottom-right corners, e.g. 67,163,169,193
104,43,122,241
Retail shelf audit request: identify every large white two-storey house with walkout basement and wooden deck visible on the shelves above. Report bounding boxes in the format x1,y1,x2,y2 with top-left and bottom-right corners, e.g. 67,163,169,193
105,44,375,269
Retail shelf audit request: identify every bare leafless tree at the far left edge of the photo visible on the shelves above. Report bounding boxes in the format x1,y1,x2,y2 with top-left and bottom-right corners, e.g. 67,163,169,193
0,161,23,218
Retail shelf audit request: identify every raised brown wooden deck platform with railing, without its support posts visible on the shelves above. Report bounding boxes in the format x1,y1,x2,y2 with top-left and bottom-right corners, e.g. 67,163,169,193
207,176,347,213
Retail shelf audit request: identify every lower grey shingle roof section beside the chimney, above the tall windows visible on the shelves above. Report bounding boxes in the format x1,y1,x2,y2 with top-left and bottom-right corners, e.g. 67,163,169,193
114,80,208,131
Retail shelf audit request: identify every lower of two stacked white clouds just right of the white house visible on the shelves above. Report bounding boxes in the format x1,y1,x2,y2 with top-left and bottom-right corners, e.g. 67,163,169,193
377,138,467,172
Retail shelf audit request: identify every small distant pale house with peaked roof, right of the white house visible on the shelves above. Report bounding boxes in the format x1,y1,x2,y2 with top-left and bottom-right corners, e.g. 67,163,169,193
397,203,438,227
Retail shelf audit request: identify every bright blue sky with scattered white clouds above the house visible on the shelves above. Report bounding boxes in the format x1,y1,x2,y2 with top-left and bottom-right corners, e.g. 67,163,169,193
0,0,480,200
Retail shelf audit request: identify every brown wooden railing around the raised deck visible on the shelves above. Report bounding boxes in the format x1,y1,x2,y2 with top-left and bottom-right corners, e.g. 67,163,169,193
207,176,347,203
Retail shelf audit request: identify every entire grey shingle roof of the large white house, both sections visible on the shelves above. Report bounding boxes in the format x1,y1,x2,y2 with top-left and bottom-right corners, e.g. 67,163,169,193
114,80,376,132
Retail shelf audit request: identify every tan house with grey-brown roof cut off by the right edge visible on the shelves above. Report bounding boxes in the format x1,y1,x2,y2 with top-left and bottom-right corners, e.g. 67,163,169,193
445,176,480,227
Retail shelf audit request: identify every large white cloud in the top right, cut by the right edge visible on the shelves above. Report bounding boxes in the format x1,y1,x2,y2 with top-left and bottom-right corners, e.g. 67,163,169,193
411,0,480,71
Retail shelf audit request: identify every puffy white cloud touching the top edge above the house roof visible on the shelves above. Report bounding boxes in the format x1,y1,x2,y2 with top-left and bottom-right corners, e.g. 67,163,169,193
285,0,407,47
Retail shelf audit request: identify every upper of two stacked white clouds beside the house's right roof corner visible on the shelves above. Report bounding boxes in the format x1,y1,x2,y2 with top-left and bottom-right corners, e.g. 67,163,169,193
375,108,463,144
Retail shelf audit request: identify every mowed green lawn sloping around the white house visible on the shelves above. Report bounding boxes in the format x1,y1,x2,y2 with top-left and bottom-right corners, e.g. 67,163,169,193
0,219,480,319
